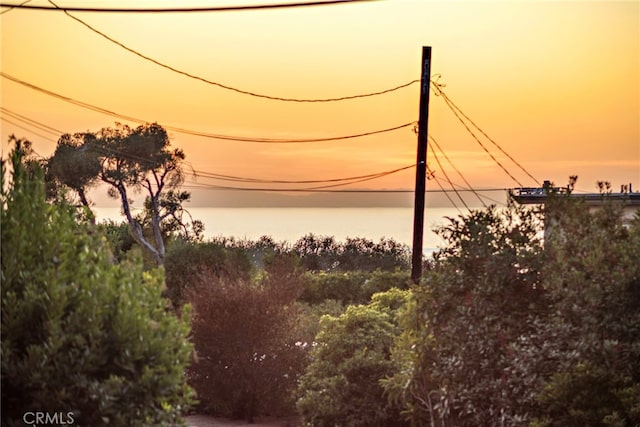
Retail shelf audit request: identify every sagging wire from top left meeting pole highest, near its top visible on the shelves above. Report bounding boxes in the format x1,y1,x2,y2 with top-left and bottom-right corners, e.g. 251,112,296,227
49,0,420,103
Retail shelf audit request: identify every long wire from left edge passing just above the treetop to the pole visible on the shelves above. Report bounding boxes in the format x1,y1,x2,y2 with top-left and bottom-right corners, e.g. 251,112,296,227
0,71,414,144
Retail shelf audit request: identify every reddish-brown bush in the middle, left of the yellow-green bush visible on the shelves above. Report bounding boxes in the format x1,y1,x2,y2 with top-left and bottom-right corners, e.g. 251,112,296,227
189,255,306,420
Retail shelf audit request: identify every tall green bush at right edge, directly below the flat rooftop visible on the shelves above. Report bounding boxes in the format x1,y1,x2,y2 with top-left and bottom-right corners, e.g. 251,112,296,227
537,194,640,426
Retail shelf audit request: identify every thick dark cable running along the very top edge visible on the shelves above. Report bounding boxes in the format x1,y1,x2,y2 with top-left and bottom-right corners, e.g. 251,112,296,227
0,0,379,13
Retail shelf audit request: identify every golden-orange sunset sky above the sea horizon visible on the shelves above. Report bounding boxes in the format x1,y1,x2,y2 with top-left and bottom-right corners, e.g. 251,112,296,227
0,0,640,204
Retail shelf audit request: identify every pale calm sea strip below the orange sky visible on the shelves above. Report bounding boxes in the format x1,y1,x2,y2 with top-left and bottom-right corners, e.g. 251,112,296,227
95,208,468,253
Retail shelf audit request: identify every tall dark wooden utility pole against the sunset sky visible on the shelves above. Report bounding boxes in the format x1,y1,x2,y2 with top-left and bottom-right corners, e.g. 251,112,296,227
411,46,431,284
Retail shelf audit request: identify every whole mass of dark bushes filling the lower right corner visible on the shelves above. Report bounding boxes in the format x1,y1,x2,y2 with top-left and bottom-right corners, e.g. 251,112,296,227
384,196,640,427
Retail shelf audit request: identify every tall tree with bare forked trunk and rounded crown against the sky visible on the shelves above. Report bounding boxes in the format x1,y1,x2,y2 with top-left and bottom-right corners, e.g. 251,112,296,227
49,123,194,265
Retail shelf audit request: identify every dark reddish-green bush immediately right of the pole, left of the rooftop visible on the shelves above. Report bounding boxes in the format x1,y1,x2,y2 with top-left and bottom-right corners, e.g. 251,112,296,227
385,208,544,426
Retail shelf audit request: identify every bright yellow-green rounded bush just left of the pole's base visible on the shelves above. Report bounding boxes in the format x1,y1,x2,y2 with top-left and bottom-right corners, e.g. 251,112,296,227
297,289,409,426
